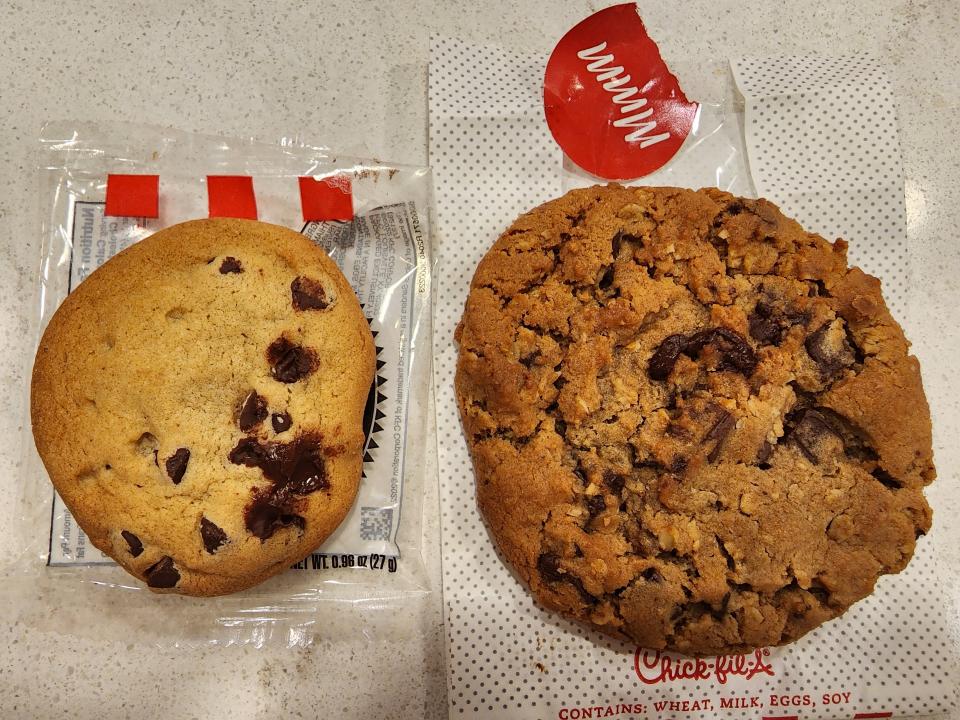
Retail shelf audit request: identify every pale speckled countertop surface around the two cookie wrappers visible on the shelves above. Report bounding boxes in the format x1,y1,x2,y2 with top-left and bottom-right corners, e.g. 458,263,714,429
0,0,960,720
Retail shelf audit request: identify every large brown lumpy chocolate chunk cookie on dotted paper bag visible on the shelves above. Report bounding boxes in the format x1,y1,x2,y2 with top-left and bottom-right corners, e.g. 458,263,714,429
456,185,935,654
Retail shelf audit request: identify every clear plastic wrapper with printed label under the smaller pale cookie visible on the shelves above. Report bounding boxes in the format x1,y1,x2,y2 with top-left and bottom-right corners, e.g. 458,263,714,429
10,123,435,645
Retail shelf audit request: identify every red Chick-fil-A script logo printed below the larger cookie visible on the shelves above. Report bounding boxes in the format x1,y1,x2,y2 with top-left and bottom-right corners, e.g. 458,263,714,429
633,648,773,685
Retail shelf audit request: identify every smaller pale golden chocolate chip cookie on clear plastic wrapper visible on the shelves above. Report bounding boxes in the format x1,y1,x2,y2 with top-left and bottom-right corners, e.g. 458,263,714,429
31,219,375,595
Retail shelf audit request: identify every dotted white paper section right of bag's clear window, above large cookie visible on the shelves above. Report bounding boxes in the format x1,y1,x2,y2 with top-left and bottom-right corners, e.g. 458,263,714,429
732,55,909,318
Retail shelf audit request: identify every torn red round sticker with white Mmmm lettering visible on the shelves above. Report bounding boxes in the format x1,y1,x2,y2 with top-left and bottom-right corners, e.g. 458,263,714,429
543,3,699,180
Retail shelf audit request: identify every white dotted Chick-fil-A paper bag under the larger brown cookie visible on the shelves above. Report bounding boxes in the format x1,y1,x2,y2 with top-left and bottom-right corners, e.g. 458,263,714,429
430,38,957,720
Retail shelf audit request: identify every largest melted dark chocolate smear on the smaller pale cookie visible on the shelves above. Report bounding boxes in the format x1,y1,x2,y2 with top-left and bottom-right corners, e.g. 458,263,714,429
229,435,330,540
